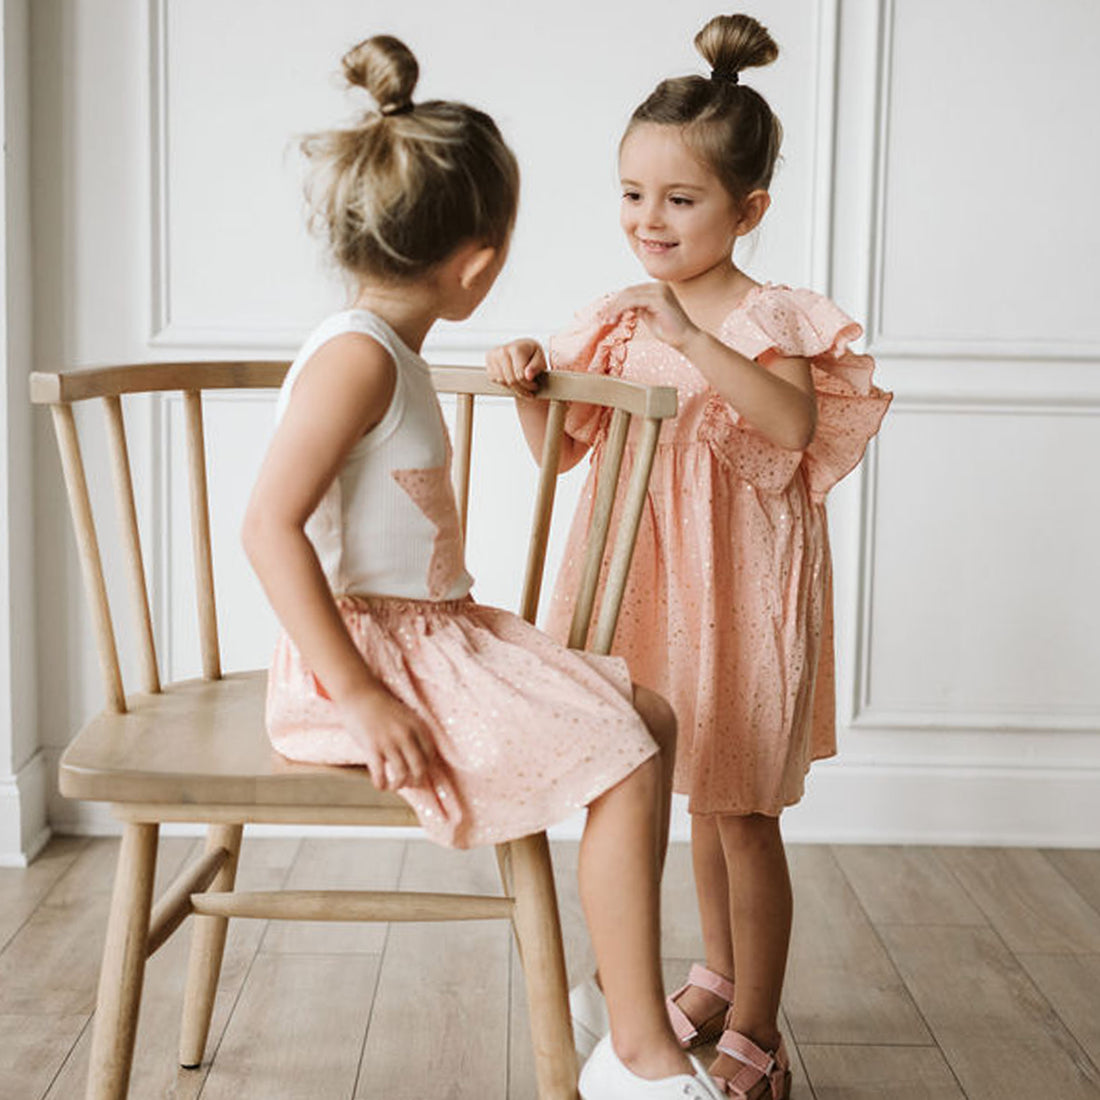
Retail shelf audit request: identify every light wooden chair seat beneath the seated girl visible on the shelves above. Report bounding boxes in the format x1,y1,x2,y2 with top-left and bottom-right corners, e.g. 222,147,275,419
61,671,416,824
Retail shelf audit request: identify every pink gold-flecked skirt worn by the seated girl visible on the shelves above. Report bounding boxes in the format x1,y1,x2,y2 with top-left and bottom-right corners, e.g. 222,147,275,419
267,596,657,848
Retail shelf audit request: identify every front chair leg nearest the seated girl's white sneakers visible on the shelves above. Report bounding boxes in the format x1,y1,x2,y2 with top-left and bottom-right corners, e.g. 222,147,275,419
508,833,576,1100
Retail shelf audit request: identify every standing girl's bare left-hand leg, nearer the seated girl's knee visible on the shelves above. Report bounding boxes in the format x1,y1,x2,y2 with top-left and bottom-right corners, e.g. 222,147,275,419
677,814,734,1024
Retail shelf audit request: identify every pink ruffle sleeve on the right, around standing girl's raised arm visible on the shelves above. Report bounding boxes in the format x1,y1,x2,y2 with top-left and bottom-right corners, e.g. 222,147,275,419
700,286,893,499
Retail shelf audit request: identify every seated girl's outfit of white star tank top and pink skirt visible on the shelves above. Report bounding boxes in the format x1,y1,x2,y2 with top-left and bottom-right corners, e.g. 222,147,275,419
267,310,657,848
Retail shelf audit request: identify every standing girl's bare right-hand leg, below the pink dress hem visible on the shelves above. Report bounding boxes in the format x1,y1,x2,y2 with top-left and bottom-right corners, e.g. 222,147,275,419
712,814,792,1076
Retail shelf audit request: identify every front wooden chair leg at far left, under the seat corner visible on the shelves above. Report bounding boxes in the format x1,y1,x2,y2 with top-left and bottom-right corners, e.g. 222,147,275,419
86,822,158,1100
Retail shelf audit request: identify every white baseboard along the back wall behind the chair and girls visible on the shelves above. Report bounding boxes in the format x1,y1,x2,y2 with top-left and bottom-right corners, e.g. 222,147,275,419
40,759,1100,848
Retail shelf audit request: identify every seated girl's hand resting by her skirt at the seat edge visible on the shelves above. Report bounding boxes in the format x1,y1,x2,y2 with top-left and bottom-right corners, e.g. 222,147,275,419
340,684,438,791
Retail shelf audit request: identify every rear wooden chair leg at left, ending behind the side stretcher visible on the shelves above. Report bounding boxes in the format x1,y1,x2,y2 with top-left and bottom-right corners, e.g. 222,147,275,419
179,825,244,1069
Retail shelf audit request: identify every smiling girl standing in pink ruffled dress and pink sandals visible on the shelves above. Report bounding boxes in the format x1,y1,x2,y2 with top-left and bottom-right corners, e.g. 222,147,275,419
488,15,890,1100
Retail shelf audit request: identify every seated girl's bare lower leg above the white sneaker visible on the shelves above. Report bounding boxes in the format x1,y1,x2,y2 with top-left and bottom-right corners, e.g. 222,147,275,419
578,757,692,1079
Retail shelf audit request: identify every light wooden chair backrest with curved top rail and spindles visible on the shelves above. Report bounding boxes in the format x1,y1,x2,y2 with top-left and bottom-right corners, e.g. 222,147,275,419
31,362,677,713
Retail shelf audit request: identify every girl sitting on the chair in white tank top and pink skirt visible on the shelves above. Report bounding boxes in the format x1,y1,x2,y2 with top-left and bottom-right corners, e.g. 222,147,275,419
243,36,721,1100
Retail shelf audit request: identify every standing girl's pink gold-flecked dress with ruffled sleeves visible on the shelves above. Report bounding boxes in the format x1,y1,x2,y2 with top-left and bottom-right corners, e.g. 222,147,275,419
547,284,891,815
